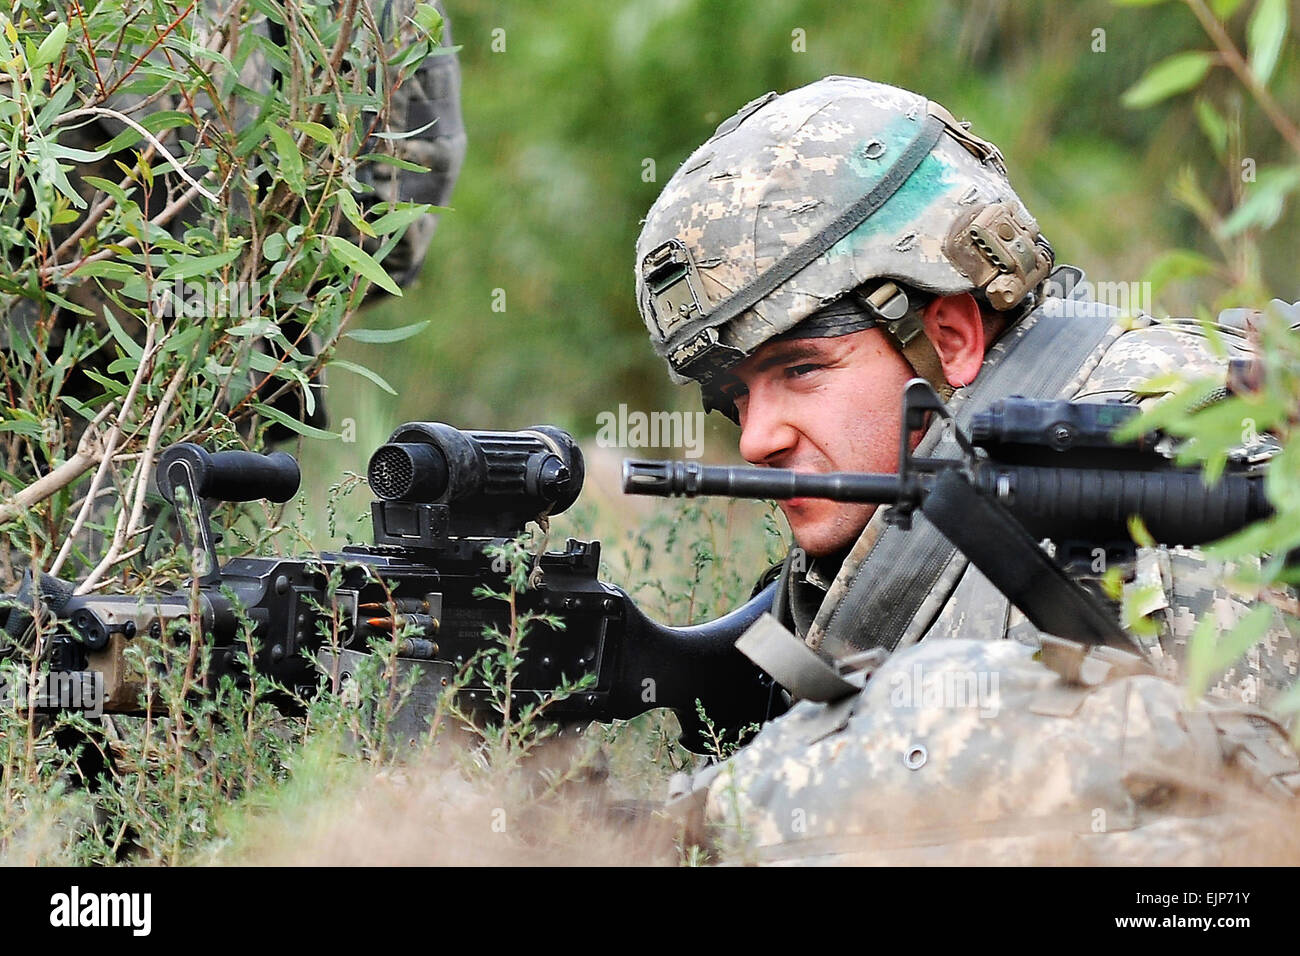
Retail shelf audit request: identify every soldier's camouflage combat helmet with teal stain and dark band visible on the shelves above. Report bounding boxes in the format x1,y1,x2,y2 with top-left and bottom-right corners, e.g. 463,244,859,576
636,77,1053,418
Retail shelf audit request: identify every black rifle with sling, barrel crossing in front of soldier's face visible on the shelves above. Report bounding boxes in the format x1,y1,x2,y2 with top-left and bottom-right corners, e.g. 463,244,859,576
623,378,1271,649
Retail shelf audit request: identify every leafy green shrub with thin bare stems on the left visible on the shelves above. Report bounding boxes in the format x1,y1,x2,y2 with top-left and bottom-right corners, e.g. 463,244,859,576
0,0,441,588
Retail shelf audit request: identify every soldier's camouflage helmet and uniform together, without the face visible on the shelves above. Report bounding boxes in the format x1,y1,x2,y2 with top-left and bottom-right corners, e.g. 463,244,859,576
637,77,1300,862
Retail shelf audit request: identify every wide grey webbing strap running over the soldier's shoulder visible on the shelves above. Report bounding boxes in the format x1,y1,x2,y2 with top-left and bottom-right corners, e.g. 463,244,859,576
810,302,1118,657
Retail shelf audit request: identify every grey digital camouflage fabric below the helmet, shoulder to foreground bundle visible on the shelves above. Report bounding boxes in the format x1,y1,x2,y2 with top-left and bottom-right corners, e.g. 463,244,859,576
696,297,1300,864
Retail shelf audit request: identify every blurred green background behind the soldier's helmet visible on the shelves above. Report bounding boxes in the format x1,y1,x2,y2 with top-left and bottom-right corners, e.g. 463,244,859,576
297,0,1300,530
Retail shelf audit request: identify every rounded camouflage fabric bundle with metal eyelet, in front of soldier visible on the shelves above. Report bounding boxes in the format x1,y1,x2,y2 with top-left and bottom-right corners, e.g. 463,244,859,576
701,640,1300,865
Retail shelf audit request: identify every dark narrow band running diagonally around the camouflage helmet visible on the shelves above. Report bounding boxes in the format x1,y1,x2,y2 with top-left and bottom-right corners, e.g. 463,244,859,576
667,114,945,354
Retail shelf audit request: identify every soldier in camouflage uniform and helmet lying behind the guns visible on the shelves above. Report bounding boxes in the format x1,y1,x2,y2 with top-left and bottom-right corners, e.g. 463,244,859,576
636,77,1300,862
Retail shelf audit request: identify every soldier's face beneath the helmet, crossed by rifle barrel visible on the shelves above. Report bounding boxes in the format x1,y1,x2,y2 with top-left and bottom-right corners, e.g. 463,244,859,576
724,329,915,557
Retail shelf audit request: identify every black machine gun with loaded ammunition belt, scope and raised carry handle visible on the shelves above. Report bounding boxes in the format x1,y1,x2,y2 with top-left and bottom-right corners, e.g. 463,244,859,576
4,421,774,750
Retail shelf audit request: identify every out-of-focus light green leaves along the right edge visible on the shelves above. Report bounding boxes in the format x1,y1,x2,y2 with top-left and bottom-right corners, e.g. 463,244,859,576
1125,0,1300,743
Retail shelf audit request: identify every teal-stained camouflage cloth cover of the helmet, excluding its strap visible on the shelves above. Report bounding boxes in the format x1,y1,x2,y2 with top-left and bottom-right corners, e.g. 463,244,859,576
637,77,1034,382
